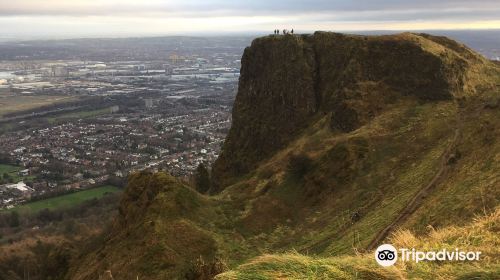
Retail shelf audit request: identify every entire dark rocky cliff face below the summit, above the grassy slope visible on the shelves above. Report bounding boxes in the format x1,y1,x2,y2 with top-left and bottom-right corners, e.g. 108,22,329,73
212,32,483,192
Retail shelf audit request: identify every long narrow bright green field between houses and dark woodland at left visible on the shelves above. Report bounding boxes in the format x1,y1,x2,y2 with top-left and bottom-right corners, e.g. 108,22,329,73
6,186,121,213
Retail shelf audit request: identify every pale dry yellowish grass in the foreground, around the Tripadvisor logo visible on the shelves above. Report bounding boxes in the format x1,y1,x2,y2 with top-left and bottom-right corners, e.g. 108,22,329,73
216,209,500,280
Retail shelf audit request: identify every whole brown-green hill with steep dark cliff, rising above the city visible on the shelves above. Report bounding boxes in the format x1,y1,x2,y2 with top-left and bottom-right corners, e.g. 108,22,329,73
68,32,500,279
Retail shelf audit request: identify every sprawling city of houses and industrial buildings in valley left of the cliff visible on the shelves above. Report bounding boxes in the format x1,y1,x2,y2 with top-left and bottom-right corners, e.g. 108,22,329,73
0,38,250,209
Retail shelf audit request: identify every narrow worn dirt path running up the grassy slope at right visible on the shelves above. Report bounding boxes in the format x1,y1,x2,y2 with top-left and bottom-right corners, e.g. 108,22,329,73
367,123,462,251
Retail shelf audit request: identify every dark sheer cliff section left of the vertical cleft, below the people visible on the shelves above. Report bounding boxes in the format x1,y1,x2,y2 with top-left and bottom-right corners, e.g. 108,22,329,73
214,36,319,192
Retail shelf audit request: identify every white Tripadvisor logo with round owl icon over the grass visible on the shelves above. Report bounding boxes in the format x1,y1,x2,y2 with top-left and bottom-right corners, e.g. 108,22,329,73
375,244,481,266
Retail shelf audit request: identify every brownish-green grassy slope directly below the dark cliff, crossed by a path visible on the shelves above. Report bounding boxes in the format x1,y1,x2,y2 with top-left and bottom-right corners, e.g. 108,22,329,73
215,94,500,255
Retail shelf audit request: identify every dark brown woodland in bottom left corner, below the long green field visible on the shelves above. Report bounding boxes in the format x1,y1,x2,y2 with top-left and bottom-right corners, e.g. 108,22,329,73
0,194,119,280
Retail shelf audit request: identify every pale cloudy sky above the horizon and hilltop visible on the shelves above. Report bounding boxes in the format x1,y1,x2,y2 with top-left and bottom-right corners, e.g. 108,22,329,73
0,0,500,38
